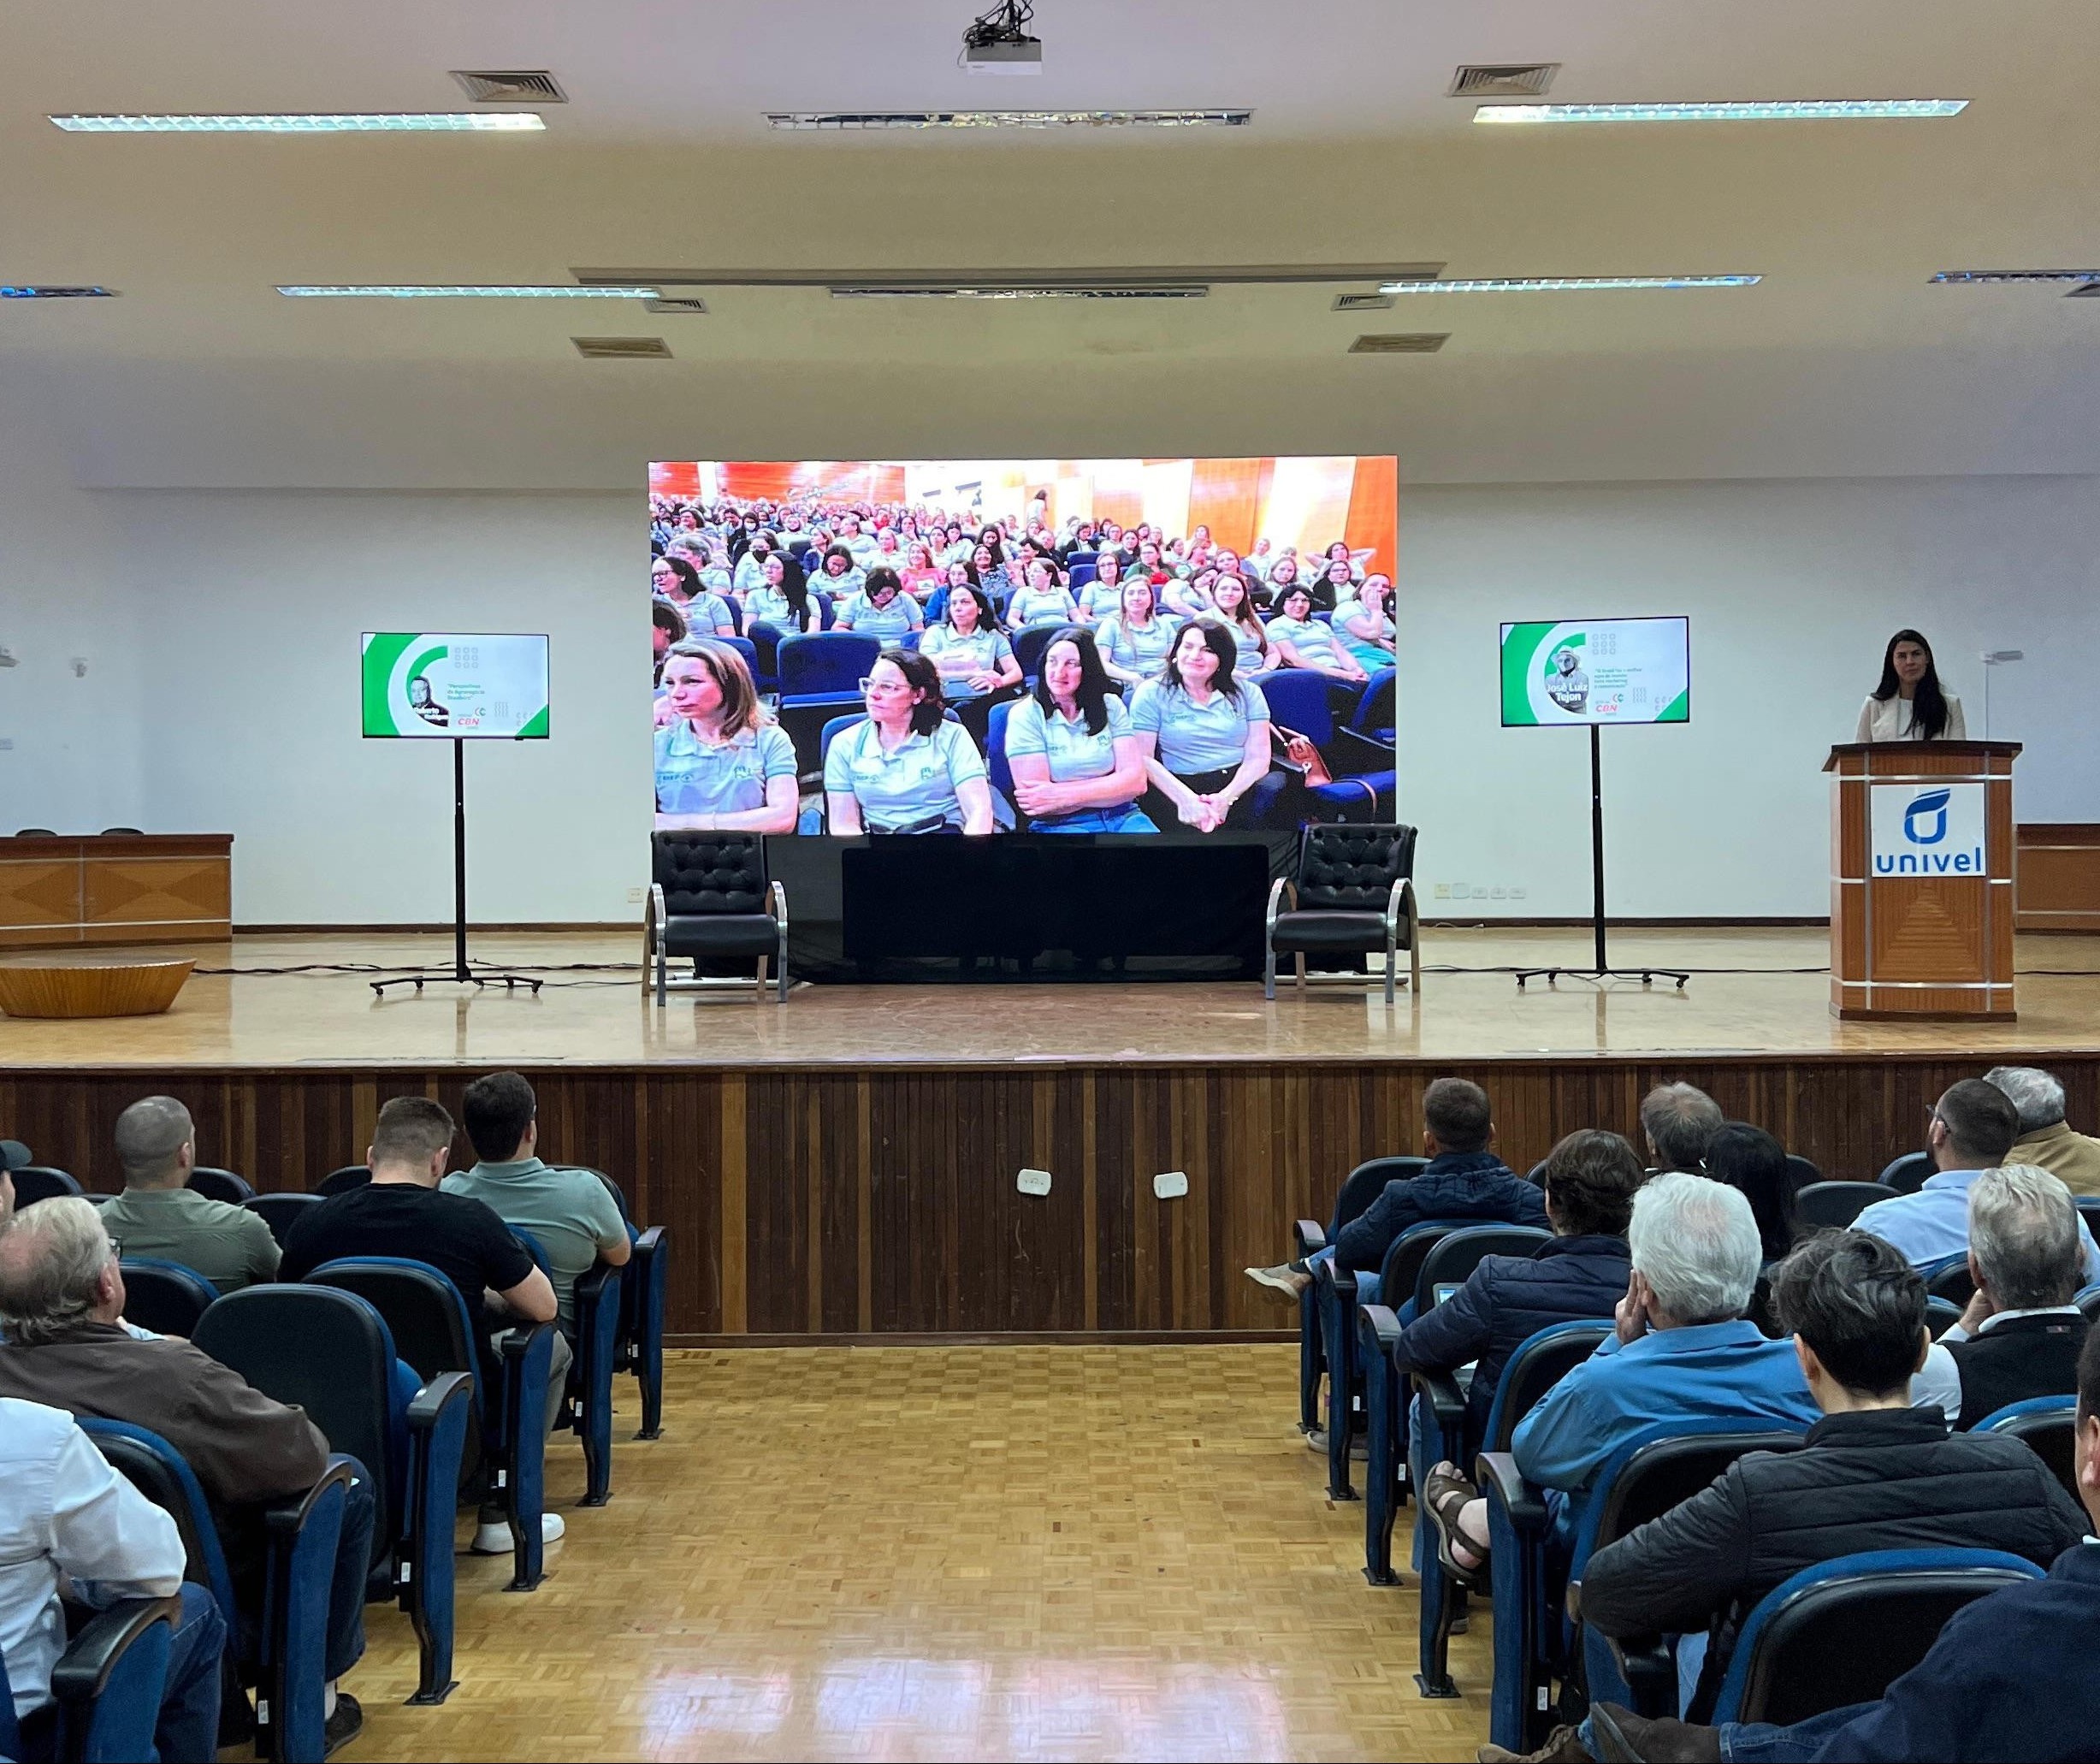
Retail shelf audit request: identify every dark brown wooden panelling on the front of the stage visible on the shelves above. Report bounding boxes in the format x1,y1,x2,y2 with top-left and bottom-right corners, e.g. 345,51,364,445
0,1052,2100,1340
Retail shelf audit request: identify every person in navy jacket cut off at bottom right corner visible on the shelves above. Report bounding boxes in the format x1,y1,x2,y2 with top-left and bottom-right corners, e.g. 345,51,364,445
1586,1334,2100,1764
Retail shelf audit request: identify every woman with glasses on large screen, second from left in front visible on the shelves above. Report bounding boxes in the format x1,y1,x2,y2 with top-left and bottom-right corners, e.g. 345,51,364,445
823,649,991,834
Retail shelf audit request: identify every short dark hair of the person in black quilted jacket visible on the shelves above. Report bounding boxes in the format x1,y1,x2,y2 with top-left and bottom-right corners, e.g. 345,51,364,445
1772,1230,1925,1396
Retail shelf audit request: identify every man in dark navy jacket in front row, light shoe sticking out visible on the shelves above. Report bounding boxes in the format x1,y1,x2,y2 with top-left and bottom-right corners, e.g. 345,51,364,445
1247,1077,1547,1323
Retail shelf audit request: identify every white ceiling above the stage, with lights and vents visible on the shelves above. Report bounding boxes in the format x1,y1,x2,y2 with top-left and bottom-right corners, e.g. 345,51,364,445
0,0,2100,489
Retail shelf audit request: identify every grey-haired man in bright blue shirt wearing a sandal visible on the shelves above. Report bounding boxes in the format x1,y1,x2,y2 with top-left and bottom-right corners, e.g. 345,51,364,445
1422,1169,1817,1587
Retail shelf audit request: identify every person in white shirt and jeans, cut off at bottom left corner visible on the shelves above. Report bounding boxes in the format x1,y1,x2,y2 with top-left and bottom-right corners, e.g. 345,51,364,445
0,1396,227,1764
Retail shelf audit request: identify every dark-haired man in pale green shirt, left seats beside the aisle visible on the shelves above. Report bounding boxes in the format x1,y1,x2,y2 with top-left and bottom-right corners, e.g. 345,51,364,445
443,1071,634,1335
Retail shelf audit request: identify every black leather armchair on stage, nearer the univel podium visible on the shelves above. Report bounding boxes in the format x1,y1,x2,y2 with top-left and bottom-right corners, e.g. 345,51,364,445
1262,823,1422,1003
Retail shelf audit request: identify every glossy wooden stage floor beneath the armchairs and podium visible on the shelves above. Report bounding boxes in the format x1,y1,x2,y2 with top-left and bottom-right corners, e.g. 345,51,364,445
0,926,2100,1071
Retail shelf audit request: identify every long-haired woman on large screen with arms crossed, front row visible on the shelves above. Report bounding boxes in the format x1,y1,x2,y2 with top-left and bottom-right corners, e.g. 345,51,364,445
1006,626,1159,834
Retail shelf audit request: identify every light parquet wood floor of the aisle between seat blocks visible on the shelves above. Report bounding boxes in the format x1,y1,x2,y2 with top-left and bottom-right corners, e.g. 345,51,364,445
340,1347,1489,1764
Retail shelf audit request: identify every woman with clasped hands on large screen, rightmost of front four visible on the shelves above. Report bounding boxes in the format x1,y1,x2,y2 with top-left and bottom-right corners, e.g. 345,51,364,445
1130,619,1270,834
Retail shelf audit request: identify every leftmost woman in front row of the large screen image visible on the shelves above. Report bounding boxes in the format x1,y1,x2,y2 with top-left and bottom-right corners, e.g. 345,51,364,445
655,636,800,834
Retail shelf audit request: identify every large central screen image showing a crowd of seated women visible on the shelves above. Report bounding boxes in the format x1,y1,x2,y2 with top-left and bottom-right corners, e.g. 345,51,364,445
649,456,1399,838
